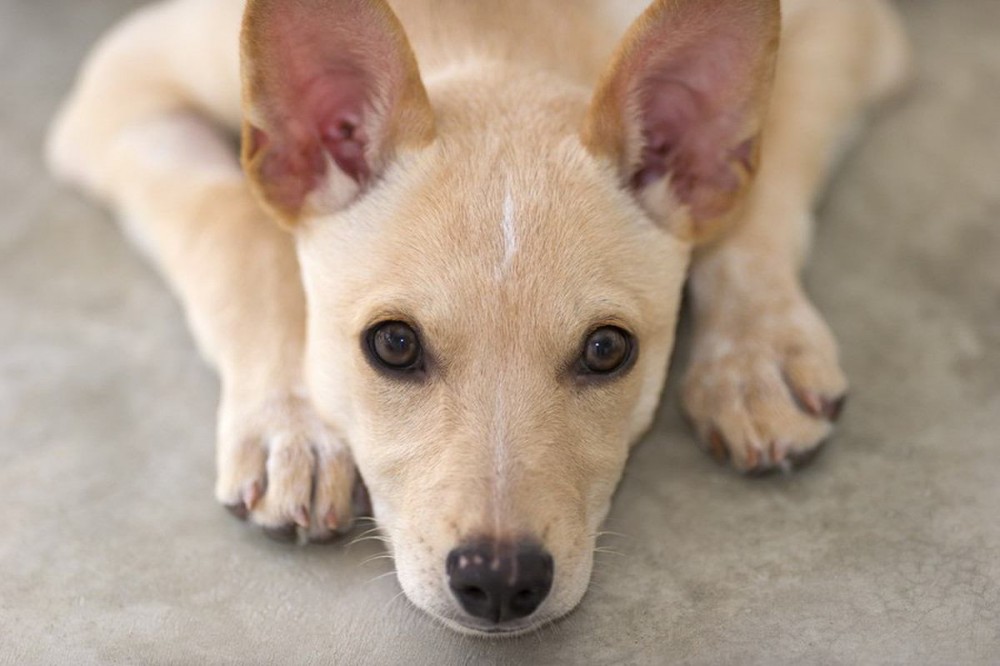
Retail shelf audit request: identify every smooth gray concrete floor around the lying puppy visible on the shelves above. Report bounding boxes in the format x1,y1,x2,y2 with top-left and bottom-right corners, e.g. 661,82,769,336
0,0,1000,664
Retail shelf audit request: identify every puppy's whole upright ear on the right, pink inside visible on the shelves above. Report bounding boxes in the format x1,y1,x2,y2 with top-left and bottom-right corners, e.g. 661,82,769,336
583,0,781,241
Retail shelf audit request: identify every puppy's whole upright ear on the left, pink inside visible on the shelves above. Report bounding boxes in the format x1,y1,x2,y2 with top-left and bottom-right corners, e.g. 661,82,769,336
241,0,434,225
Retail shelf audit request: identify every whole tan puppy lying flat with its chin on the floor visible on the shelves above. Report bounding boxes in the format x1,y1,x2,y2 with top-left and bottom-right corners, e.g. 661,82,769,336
48,0,909,635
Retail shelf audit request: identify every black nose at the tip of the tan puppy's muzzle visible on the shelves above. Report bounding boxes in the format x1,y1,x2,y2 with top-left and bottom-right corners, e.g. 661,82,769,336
446,541,553,623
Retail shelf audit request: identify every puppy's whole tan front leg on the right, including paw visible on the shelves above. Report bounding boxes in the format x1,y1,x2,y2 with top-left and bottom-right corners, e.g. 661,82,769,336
683,0,906,472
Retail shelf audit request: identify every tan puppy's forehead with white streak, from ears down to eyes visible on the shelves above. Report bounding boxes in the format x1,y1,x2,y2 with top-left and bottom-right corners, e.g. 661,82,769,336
306,142,688,334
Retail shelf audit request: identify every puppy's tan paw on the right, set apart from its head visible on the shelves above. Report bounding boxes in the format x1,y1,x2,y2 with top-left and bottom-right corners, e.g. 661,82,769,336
683,296,847,473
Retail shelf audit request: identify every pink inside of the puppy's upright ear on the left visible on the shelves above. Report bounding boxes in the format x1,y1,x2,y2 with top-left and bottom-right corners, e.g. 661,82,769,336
244,0,398,211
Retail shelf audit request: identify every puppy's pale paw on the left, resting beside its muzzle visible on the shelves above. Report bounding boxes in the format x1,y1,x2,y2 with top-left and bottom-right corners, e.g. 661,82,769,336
215,395,361,542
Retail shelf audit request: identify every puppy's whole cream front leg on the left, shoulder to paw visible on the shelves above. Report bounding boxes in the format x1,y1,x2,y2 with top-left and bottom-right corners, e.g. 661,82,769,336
49,3,356,540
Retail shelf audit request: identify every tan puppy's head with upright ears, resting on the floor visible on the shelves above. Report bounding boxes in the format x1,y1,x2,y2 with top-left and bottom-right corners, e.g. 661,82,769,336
243,0,778,632
